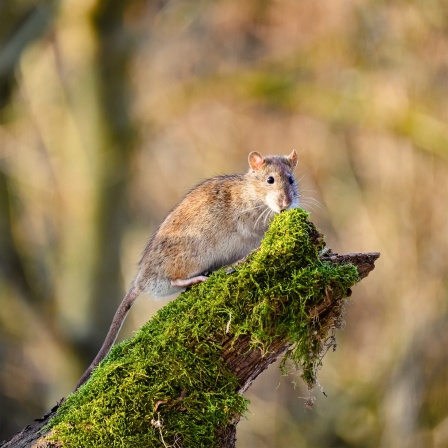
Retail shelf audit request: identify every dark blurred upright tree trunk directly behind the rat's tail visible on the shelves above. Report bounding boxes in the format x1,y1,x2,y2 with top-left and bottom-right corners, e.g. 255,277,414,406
77,0,135,362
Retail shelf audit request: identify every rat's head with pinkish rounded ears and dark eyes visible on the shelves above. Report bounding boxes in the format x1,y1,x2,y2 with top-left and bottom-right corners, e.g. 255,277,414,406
248,149,299,213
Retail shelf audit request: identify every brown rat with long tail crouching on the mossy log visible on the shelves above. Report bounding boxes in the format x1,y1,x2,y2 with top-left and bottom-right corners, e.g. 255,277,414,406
75,150,299,390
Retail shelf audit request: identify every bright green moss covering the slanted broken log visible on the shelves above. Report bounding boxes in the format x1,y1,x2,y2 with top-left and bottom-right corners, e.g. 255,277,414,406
49,209,358,448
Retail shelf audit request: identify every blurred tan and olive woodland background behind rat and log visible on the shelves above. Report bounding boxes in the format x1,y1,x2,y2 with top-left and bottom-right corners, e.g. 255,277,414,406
0,0,448,448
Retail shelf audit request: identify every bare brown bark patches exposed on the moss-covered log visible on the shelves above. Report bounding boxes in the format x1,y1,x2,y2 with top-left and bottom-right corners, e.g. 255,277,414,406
0,252,380,448
